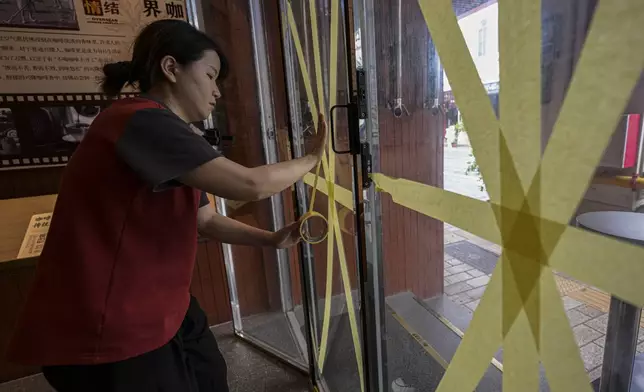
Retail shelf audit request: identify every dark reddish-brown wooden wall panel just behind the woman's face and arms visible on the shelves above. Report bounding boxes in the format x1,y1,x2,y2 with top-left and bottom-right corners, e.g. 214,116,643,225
204,0,280,315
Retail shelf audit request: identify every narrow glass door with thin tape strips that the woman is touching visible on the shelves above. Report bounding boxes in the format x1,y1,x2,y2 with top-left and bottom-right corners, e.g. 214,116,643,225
280,0,368,391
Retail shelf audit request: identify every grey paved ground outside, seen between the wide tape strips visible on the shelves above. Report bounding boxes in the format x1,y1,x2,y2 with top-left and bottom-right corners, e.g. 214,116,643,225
444,224,644,380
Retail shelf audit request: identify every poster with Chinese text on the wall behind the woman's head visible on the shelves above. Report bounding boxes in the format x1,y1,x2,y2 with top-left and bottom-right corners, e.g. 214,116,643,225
0,0,186,96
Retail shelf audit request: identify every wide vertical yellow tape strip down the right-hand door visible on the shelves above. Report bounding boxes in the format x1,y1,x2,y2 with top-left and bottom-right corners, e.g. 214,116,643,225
497,0,543,392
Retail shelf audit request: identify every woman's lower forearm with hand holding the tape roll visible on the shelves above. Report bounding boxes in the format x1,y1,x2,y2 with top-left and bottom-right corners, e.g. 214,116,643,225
197,204,299,248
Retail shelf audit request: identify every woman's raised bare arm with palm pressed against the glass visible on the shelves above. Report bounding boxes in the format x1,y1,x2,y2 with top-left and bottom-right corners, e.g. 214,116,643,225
179,112,327,201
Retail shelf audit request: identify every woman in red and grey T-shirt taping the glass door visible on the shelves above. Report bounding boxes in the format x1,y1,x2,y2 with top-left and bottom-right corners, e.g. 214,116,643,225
5,20,326,392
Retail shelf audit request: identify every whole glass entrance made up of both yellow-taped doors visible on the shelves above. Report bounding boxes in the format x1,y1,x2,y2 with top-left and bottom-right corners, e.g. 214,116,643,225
223,0,644,391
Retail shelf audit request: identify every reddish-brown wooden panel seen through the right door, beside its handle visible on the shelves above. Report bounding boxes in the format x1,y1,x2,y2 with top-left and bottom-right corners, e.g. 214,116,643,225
375,0,443,298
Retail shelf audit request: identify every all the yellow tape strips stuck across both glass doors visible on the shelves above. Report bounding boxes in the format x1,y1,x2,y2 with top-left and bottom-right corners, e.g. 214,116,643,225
288,0,644,392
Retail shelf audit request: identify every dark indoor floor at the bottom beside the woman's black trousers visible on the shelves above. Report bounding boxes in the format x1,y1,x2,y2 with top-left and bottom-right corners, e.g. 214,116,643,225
0,325,308,392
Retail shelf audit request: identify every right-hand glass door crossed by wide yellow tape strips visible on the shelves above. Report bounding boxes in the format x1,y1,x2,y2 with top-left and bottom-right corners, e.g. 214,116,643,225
354,0,644,392
